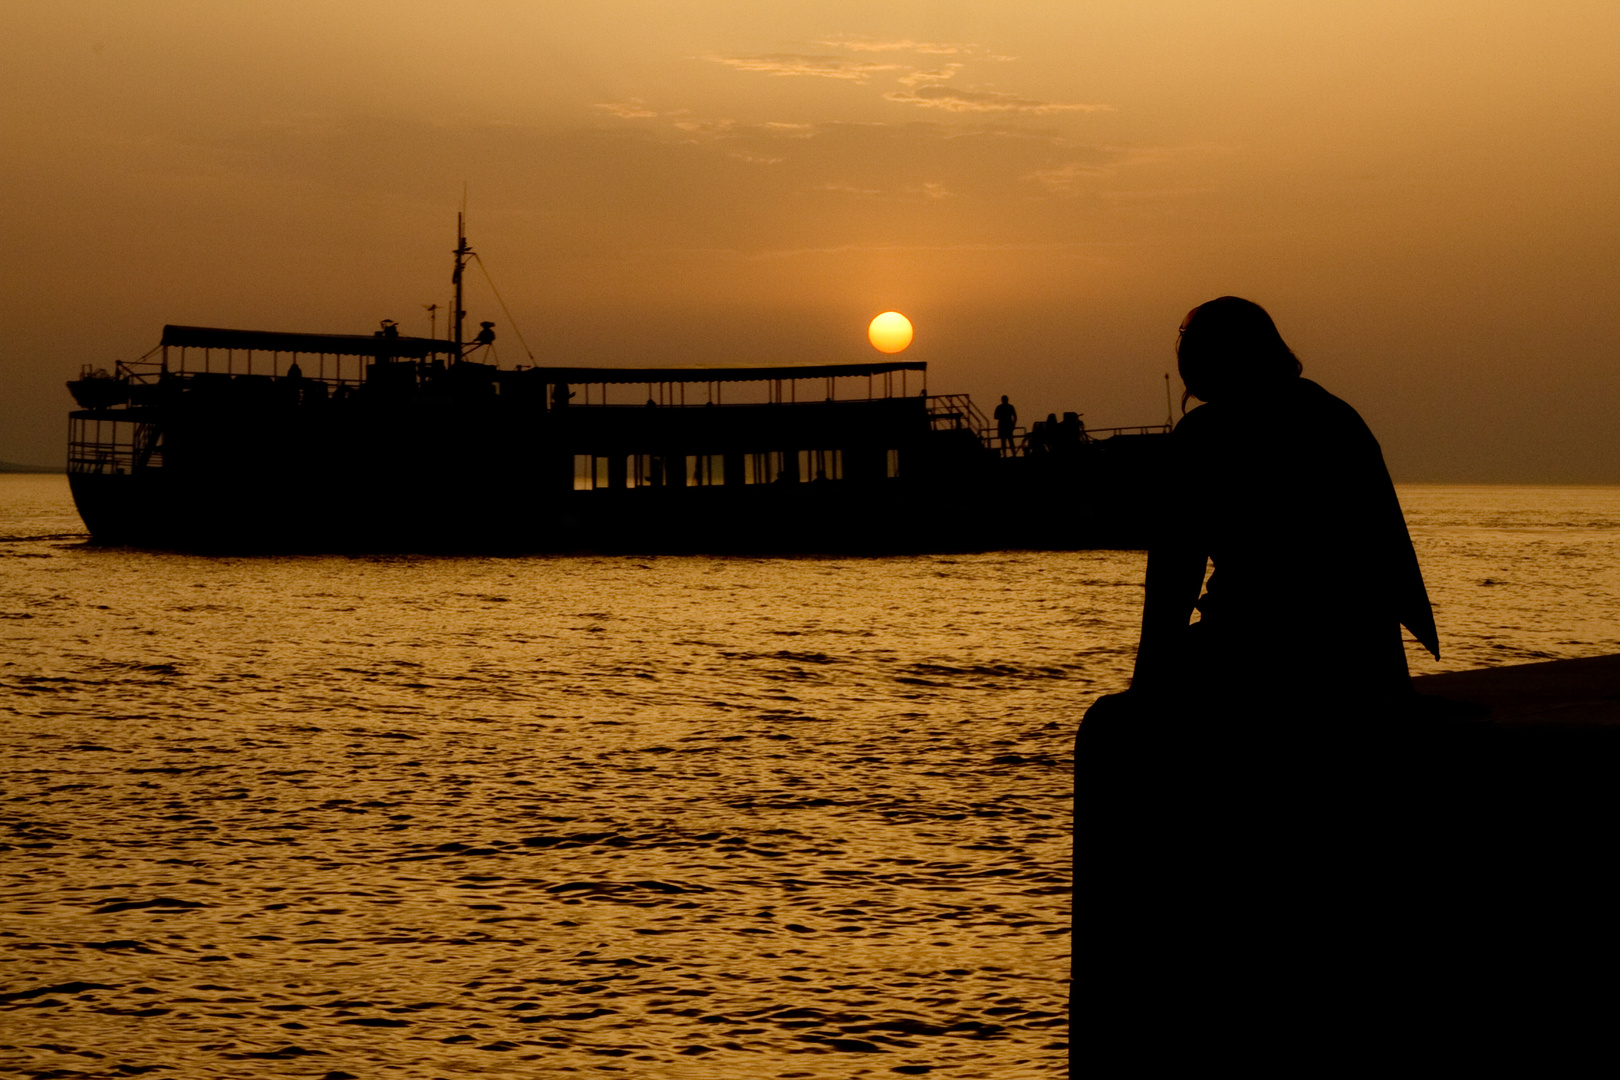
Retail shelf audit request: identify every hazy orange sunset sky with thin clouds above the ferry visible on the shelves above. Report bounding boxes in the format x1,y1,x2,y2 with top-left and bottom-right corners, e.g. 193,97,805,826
0,0,1620,483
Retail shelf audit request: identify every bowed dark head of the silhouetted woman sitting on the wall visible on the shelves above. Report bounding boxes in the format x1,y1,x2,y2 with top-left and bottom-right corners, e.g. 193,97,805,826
1176,296,1304,411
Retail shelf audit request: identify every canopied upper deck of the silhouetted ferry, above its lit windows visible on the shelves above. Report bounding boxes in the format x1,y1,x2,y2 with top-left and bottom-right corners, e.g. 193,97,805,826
70,325,930,470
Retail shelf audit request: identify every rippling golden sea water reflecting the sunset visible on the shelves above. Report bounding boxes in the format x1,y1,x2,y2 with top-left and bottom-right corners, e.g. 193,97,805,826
0,474,1620,1080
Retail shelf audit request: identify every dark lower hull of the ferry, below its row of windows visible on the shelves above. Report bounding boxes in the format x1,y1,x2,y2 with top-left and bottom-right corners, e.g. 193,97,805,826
59,453,1149,554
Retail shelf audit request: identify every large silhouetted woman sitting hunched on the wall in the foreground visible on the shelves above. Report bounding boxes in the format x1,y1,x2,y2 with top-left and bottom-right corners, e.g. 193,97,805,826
1131,296,1439,724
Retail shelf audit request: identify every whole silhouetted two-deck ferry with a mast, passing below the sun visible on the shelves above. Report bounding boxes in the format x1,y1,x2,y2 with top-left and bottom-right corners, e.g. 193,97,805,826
68,230,1168,554
